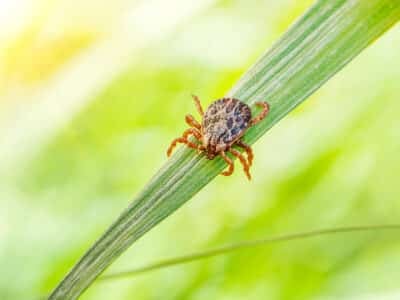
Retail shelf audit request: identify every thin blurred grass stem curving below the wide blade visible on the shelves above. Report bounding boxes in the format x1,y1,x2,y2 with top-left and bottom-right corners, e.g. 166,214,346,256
99,224,400,280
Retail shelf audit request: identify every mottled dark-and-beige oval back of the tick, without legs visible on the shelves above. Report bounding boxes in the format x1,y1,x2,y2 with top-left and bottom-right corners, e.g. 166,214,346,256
202,98,251,148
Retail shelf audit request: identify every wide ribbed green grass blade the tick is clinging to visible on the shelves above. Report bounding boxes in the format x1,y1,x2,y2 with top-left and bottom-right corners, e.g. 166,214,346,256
50,0,400,299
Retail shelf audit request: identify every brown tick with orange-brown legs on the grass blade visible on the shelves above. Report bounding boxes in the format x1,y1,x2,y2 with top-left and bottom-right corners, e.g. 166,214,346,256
167,96,269,180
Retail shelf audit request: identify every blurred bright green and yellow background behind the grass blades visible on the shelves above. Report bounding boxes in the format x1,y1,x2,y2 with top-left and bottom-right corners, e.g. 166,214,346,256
0,0,400,300
